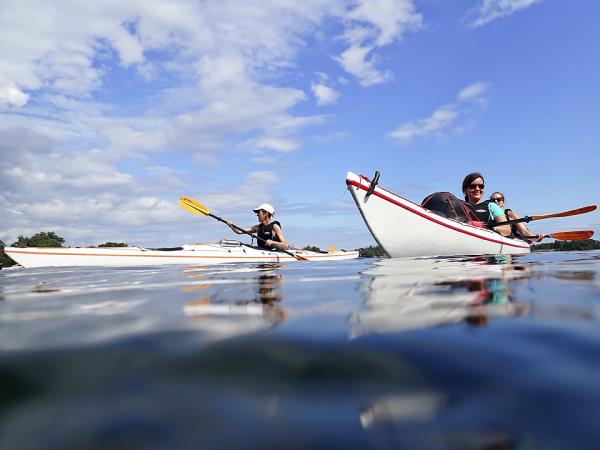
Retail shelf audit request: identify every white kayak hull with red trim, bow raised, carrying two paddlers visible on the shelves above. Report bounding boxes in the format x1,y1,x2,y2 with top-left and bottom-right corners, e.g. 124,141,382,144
346,172,530,258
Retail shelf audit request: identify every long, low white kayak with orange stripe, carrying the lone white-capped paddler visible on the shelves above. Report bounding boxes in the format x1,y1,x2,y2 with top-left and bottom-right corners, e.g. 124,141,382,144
4,240,358,267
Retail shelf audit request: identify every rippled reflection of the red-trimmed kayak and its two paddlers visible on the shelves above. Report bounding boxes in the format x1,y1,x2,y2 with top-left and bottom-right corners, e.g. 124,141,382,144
350,256,530,337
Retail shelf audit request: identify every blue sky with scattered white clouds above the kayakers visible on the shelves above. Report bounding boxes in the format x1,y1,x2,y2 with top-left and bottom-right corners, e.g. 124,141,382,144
0,0,600,249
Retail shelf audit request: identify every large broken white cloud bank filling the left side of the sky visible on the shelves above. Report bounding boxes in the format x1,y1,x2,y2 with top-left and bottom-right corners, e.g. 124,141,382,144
0,0,422,244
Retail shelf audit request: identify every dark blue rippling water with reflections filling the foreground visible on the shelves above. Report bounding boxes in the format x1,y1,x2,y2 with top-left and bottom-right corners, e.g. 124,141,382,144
0,252,600,450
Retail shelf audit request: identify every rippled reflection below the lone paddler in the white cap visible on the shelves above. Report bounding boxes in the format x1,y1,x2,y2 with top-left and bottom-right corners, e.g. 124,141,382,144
183,264,286,338
